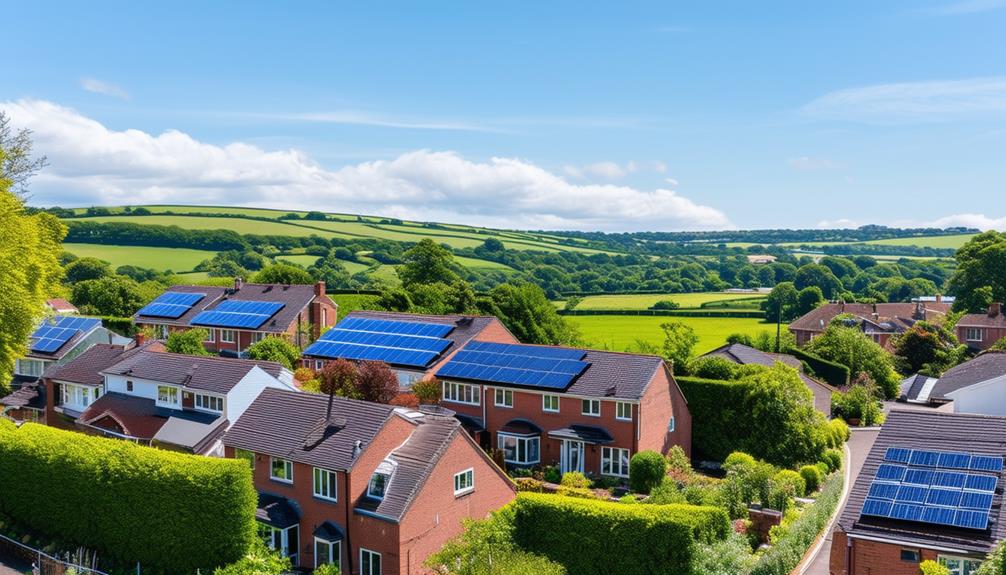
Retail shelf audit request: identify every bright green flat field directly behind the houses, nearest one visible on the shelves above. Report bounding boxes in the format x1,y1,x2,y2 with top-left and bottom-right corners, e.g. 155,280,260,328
565,316,786,355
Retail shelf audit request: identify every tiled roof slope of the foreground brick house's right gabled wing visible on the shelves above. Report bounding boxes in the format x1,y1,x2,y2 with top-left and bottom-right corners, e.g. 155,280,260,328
356,416,461,521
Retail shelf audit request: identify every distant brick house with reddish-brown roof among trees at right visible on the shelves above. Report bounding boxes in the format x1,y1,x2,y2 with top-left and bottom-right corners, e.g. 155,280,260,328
789,296,951,349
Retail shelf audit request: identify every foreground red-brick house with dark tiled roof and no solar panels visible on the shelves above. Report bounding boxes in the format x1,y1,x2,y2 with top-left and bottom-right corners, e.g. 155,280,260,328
223,389,515,575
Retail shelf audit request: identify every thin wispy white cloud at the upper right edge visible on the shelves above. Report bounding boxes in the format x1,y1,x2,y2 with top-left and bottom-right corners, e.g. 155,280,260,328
801,76,1006,124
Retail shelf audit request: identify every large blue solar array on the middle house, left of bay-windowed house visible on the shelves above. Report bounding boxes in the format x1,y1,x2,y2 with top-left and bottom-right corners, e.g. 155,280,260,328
304,318,454,367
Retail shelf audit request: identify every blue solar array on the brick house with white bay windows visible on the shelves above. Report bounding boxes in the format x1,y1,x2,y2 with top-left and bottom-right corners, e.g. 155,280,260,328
437,342,591,390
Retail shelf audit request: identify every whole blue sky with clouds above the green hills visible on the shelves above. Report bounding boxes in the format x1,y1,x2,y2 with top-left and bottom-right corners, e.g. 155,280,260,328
0,0,1006,230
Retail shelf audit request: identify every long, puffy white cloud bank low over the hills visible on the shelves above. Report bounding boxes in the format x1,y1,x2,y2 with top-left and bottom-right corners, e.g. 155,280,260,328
0,100,732,230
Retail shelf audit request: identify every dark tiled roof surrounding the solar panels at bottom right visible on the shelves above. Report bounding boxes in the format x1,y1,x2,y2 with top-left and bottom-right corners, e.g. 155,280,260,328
838,409,1006,553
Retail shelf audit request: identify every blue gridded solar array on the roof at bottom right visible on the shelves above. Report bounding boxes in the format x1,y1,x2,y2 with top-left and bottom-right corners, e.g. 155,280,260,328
862,447,1003,530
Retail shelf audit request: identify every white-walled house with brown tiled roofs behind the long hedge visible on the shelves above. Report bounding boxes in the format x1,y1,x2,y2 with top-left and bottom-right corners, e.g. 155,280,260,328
43,342,296,455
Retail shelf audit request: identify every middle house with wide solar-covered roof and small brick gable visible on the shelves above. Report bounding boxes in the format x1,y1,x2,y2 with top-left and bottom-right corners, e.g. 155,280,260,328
301,311,517,391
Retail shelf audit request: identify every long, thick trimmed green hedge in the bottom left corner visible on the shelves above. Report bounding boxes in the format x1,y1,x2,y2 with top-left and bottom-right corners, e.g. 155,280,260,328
0,420,258,575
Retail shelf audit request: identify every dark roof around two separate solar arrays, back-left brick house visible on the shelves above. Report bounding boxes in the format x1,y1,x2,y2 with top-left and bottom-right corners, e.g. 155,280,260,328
133,283,315,332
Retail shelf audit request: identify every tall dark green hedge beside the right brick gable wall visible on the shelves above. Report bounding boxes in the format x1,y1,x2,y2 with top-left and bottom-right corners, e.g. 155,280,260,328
674,376,750,461
